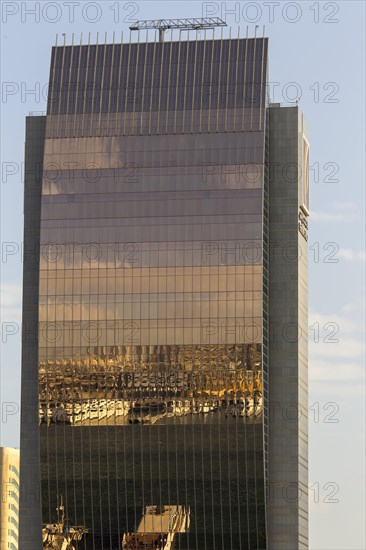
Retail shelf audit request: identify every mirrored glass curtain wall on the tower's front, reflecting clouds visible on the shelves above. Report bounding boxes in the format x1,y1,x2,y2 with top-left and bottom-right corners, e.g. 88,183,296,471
27,33,267,550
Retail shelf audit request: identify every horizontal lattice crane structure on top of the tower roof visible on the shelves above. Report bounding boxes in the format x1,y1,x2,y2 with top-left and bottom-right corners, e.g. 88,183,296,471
130,17,227,42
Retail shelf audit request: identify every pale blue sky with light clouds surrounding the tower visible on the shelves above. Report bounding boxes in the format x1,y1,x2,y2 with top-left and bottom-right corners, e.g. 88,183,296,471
1,0,366,550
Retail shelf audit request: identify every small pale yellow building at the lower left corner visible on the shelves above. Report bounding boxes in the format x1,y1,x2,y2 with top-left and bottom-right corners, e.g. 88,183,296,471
0,447,19,550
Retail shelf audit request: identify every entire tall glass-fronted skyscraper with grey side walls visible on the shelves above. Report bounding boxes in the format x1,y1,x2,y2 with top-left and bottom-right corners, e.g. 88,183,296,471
20,25,308,550
